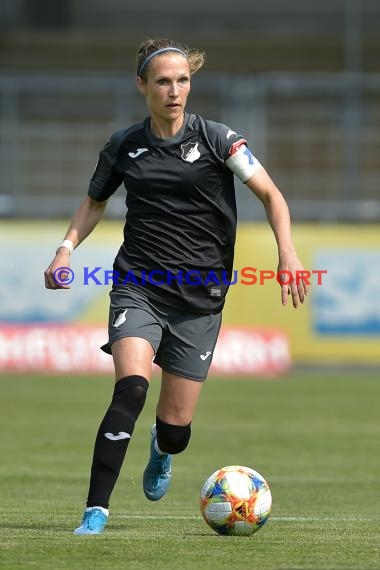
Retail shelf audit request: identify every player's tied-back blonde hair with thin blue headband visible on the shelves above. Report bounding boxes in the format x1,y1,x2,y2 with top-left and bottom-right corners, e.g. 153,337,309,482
136,38,205,79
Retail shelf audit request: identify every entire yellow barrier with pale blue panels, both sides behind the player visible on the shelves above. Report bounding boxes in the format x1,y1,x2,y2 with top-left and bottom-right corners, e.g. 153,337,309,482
0,221,380,364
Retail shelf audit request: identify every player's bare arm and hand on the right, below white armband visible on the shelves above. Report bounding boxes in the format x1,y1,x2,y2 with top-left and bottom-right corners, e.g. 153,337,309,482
245,168,309,309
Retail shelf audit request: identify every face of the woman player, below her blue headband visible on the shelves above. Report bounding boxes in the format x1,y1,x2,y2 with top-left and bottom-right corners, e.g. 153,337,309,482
137,52,190,123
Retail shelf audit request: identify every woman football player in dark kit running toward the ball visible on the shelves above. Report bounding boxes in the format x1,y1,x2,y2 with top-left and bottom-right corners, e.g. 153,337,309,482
45,39,308,535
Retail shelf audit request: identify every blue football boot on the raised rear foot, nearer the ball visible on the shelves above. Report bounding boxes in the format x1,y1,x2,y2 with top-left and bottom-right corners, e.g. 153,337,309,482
143,424,172,501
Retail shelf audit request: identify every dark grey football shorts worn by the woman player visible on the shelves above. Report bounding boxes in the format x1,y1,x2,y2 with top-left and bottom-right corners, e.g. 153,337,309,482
102,286,222,382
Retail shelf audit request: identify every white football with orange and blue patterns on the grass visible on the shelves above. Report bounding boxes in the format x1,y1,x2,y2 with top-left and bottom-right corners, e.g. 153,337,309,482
200,465,272,536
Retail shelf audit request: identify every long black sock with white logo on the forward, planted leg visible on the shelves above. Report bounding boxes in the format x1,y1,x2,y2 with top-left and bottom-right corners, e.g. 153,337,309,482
87,376,149,508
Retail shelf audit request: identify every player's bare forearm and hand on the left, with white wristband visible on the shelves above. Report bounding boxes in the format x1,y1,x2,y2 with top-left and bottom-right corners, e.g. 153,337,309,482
44,196,107,289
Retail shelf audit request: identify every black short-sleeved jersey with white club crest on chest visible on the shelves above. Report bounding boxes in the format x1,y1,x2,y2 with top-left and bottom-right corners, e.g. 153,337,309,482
88,114,245,313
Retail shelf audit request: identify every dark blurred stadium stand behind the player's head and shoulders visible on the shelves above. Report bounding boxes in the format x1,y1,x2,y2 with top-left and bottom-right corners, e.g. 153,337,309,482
0,0,380,222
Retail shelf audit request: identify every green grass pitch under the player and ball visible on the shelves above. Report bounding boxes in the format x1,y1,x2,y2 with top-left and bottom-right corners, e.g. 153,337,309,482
0,371,380,570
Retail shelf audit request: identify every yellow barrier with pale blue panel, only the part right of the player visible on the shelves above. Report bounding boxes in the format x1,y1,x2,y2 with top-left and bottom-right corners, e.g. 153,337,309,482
224,224,380,363
